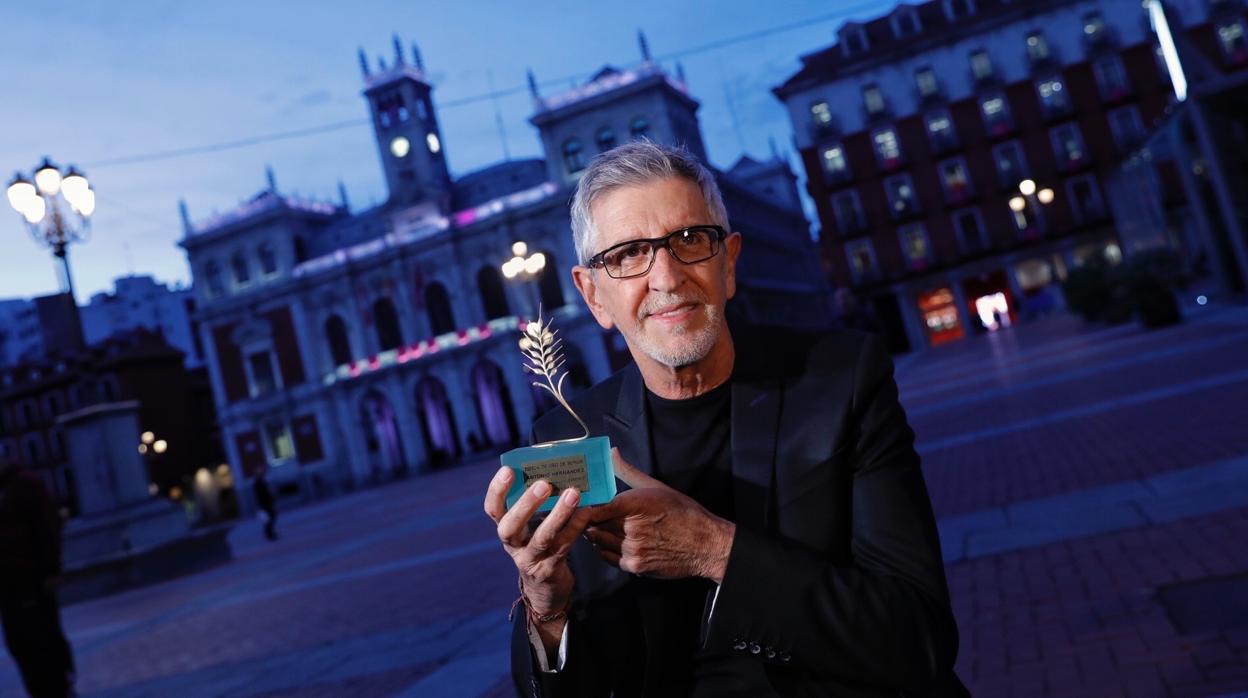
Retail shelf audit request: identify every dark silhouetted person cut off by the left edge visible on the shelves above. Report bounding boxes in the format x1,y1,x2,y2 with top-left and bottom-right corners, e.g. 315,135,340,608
0,445,74,698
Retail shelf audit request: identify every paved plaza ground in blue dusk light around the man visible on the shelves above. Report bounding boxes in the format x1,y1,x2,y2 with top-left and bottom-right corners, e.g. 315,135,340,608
0,307,1248,697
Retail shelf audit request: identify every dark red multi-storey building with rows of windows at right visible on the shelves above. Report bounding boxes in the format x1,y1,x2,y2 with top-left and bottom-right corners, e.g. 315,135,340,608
774,0,1242,351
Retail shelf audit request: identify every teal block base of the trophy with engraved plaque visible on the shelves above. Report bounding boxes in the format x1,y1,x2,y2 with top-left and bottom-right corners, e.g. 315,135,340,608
503,436,615,512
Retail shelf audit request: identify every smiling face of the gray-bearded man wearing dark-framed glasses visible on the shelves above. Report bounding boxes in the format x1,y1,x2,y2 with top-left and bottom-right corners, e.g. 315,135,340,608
573,177,741,367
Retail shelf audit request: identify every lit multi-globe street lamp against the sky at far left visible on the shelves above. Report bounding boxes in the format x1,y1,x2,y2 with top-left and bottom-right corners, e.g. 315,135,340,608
7,157,95,298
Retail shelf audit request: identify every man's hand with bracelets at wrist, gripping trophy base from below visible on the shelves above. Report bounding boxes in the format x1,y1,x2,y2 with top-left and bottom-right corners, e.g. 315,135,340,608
485,466,589,652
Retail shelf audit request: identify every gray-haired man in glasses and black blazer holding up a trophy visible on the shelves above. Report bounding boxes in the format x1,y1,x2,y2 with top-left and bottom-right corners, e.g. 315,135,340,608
485,141,966,697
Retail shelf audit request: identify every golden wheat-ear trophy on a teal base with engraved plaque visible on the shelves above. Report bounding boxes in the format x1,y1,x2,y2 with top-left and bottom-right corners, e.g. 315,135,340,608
502,311,615,512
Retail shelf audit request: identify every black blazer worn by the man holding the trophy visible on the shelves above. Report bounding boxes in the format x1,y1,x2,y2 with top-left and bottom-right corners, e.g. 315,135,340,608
512,327,967,698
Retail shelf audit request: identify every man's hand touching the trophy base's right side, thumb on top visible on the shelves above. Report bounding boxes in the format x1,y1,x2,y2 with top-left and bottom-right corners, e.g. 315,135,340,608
585,448,736,583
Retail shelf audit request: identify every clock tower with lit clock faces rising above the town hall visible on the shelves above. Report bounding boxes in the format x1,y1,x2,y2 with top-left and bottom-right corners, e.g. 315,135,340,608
359,36,451,212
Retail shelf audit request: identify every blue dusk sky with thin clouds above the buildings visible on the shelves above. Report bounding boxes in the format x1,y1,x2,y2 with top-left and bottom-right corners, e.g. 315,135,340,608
0,0,892,302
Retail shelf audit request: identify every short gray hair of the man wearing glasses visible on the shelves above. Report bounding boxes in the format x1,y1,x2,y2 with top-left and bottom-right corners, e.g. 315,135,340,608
572,139,729,263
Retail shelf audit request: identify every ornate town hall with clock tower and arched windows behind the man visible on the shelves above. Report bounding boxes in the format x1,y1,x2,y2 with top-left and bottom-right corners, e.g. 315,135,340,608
181,35,827,496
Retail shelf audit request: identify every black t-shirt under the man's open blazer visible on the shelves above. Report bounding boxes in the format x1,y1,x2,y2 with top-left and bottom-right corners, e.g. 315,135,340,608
638,381,766,696
